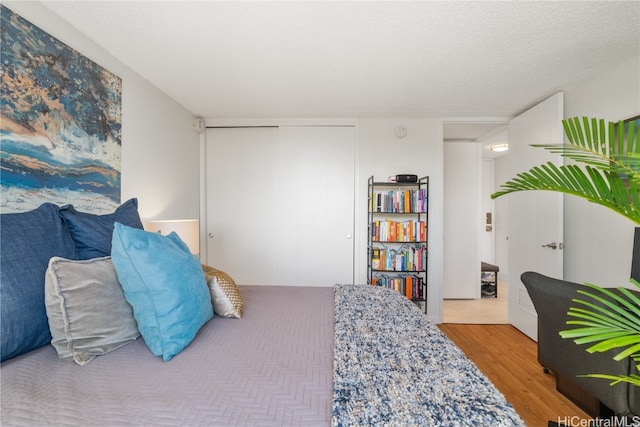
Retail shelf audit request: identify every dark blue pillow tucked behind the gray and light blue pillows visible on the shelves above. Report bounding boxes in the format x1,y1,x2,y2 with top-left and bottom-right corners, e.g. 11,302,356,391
58,198,143,259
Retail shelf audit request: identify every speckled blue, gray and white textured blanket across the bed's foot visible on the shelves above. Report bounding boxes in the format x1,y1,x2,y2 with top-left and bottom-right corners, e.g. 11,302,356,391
332,285,524,427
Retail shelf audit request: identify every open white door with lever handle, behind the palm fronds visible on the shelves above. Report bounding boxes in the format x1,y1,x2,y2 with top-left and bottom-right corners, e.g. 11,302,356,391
504,93,564,340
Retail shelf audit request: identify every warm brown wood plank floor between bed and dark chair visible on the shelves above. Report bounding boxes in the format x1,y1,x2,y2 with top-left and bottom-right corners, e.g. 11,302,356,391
439,324,589,427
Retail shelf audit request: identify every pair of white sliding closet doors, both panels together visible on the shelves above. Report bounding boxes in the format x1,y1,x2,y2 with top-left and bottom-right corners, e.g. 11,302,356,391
206,126,355,286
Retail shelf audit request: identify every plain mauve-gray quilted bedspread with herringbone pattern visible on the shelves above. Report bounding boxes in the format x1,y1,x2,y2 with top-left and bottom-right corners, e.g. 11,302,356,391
0,286,334,427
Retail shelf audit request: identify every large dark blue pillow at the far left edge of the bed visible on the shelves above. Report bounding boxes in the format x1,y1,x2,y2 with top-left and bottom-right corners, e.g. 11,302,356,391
0,203,77,361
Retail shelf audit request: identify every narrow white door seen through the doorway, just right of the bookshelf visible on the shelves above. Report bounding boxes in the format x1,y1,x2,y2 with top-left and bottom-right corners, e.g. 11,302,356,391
443,142,482,299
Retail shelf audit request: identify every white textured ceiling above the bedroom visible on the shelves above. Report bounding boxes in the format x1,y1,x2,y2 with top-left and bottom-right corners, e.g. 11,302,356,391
43,1,640,118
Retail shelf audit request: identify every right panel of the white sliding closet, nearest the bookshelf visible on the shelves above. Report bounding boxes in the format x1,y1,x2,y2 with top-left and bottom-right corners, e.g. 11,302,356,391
277,126,354,286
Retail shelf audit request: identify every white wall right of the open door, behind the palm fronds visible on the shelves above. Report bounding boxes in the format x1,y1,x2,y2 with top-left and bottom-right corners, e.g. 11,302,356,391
564,56,640,286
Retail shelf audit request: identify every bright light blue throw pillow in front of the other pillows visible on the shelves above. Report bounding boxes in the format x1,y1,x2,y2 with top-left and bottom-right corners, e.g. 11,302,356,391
111,223,213,362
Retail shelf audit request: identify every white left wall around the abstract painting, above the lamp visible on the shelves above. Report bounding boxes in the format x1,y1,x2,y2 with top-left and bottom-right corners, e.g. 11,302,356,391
3,1,200,224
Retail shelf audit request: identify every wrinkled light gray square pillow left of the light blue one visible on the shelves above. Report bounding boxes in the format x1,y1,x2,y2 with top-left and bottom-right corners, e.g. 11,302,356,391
45,257,140,365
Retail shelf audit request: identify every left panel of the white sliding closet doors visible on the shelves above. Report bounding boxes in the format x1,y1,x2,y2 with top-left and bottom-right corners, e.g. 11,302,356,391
205,127,278,284
